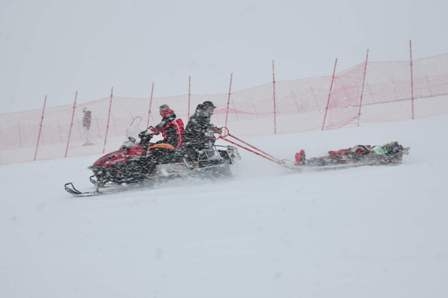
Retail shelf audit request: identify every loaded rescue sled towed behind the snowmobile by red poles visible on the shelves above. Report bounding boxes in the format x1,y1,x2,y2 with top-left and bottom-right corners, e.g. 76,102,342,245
295,141,409,169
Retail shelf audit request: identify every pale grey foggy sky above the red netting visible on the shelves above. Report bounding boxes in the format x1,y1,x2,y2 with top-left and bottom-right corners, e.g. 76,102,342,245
0,0,448,112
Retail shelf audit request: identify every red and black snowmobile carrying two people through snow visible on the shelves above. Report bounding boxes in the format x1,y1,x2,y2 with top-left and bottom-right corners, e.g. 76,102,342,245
64,131,241,196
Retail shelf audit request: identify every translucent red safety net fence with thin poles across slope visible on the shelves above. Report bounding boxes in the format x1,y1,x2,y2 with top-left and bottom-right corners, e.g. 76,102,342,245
0,54,448,164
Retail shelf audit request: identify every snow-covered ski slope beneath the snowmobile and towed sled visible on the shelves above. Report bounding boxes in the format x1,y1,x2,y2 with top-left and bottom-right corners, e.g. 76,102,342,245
0,116,448,298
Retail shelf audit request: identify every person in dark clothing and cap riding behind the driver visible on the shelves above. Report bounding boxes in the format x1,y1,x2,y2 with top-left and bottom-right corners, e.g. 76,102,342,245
185,100,222,161
